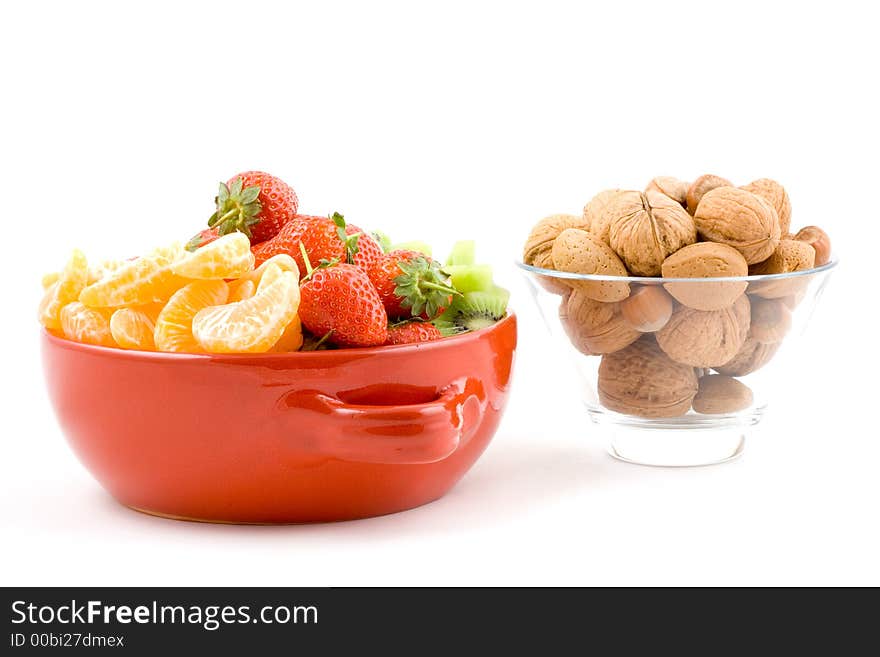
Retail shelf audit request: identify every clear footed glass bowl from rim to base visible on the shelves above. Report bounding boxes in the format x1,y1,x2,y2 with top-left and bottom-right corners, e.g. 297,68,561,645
516,260,837,466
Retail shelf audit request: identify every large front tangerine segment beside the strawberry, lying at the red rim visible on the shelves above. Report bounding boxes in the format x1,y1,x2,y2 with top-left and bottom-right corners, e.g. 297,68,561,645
192,271,299,353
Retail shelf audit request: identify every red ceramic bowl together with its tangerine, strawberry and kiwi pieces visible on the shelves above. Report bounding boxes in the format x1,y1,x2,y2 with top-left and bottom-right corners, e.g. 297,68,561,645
38,172,516,523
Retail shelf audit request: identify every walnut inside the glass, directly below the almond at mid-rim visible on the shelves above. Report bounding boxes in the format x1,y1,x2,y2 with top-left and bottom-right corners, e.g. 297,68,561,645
655,295,750,367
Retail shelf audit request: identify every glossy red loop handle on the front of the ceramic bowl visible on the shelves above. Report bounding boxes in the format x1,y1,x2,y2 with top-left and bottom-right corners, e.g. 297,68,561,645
283,382,482,465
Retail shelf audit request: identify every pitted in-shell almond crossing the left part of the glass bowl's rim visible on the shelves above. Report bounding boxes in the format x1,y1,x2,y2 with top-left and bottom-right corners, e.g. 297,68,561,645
551,228,629,301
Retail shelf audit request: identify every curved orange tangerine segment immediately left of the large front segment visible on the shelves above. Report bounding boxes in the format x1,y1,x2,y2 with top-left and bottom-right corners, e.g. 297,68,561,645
153,281,229,353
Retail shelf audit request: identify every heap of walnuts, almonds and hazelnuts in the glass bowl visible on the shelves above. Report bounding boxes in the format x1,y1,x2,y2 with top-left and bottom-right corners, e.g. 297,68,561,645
523,175,831,418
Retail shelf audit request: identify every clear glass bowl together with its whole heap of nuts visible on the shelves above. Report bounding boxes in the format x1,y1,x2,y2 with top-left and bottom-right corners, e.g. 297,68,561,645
520,175,836,465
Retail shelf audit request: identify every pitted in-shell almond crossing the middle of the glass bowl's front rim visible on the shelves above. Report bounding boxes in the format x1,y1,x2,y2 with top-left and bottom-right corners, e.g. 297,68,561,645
661,242,749,310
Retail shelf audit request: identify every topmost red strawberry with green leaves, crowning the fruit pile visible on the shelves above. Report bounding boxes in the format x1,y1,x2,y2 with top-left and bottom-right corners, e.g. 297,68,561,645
208,171,299,244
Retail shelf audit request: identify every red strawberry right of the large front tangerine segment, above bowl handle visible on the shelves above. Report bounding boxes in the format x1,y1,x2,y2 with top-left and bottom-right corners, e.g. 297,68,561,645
299,261,388,347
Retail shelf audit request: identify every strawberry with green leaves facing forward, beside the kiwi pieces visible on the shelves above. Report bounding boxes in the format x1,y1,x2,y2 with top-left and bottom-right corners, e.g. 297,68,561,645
368,250,458,319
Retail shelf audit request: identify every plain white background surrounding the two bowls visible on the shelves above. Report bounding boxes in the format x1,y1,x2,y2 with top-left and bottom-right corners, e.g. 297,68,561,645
0,1,880,585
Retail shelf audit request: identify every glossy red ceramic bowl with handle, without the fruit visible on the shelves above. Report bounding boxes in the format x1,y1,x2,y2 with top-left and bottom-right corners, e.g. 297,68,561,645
42,315,516,523
